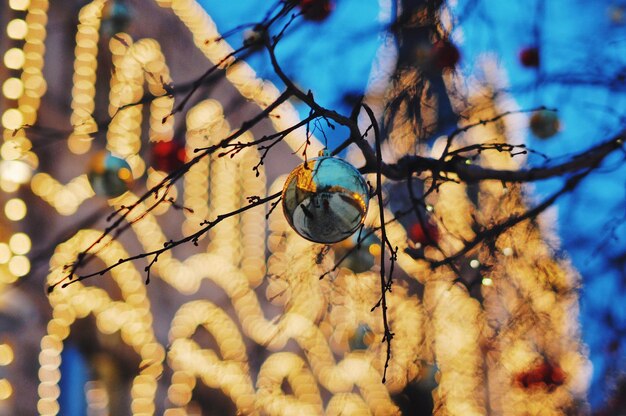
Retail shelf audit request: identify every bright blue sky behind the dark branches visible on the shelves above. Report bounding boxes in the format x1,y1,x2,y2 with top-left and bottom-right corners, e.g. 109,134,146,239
204,0,626,407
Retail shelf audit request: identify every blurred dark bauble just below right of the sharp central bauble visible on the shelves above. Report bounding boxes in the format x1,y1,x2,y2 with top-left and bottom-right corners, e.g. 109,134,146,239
335,229,380,273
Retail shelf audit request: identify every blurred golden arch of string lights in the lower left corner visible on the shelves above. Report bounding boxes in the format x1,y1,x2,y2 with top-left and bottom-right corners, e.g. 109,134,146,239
44,230,165,415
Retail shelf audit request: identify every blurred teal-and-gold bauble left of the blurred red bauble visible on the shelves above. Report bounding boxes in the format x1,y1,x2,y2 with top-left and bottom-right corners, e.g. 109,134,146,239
87,151,132,198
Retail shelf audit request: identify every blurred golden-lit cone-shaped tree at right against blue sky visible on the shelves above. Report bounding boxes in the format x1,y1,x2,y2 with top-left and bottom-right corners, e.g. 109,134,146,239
416,88,590,415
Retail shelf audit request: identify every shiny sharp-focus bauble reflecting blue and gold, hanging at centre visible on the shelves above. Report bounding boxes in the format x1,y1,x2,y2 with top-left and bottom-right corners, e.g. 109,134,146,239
282,154,369,244
